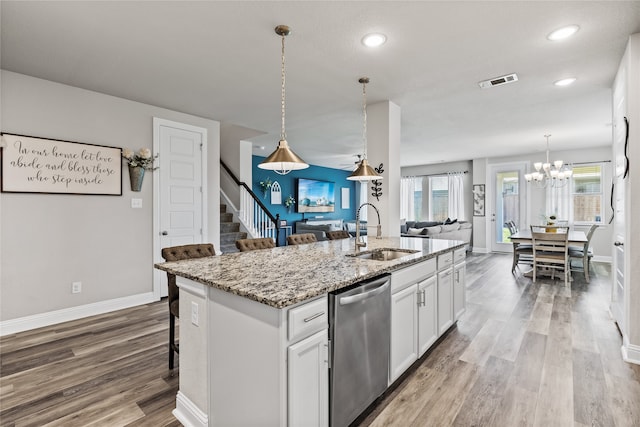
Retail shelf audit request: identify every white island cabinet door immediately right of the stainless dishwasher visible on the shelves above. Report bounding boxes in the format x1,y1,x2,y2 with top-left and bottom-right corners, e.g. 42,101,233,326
389,284,418,384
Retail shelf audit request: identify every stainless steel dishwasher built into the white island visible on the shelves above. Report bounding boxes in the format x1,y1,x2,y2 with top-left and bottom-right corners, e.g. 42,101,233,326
329,275,391,427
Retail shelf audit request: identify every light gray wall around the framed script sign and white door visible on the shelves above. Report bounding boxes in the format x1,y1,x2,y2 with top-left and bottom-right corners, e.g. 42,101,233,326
0,71,220,321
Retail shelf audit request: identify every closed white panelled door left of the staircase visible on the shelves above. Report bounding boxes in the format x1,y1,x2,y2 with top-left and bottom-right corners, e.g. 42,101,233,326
154,118,207,297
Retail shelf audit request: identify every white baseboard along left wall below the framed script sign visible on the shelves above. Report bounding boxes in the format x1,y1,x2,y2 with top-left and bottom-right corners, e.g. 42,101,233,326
0,292,158,336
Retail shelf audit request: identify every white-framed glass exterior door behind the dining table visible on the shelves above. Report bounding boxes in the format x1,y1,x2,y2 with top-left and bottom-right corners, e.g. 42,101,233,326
486,163,527,252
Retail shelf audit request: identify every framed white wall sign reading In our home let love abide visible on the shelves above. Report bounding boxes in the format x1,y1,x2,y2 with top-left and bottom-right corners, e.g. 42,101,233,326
0,133,122,196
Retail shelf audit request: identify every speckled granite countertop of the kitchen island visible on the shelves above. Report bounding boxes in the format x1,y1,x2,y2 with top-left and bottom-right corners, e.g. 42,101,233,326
155,237,466,308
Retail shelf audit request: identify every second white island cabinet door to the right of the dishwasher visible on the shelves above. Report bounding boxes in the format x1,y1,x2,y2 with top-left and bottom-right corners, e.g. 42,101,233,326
418,275,438,357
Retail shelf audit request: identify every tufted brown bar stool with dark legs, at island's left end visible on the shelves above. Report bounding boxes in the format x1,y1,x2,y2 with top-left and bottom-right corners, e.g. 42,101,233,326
161,243,216,369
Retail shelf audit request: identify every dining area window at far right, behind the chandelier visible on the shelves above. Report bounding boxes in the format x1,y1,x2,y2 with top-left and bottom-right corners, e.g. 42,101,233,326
571,164,603,223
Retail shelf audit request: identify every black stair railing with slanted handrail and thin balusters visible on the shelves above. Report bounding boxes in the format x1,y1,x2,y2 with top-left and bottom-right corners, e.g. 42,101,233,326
220,160,280,246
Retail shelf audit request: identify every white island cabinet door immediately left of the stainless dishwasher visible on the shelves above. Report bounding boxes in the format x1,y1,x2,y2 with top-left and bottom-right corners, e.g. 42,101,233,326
288,329,329,427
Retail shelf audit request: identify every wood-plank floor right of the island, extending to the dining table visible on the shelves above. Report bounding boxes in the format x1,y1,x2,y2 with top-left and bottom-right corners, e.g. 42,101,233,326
358,255,640,427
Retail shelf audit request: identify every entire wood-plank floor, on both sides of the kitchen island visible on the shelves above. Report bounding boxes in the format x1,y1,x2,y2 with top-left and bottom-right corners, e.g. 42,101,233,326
0,255,640,427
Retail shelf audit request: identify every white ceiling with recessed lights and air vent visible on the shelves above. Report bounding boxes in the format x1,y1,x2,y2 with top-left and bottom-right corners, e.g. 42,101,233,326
0,0,640,171
